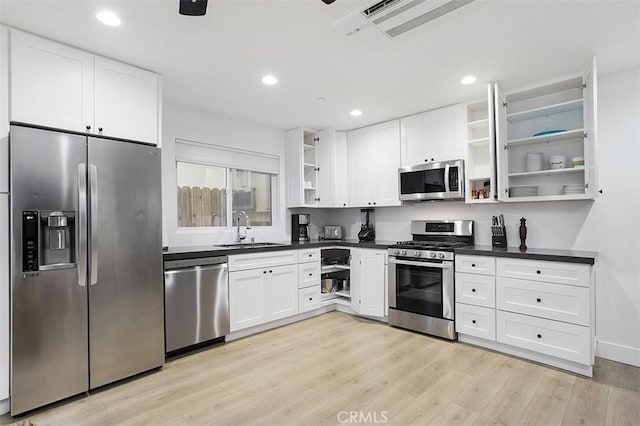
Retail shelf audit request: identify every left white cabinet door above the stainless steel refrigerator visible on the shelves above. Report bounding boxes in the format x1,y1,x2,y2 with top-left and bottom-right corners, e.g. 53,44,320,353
11,30,94,132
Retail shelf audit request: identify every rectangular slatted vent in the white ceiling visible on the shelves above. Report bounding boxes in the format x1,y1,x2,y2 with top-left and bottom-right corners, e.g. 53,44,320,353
333,0,473,38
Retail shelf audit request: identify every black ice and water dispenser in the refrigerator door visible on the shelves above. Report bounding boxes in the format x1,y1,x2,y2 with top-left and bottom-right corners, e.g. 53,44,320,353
22,210,76,272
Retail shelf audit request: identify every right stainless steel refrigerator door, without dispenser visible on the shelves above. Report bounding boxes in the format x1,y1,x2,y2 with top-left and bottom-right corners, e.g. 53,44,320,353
87,138,164,389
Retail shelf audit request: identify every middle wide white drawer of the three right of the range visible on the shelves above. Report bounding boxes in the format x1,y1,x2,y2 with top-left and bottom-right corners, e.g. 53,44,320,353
496,277,590,326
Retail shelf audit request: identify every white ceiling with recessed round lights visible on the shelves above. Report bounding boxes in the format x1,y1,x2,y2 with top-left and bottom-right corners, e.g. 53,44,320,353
0,0,640,130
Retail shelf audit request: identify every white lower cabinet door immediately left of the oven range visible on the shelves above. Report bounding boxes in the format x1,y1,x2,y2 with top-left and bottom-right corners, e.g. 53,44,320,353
350,249,387,317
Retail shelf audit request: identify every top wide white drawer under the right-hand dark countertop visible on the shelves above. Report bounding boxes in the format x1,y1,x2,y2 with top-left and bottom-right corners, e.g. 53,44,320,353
496,258,590,287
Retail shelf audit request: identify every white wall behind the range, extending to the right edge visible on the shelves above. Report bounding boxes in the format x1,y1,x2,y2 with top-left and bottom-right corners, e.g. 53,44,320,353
326,69,640,366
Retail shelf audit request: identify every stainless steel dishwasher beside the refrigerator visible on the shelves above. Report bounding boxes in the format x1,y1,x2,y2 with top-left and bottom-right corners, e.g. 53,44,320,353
164,256,229,352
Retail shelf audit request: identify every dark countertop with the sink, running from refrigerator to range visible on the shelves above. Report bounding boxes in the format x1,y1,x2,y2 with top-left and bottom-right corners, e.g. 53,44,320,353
162,239,395,261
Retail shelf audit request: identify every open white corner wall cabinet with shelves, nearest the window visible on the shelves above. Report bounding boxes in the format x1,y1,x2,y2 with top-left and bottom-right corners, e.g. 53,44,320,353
285,128,346,208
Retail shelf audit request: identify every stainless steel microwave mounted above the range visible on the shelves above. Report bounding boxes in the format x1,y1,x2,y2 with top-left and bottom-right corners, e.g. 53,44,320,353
398,160,464,201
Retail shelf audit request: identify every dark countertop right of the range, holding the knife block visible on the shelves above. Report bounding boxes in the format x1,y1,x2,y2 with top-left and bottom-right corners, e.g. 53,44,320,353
455,246,598,265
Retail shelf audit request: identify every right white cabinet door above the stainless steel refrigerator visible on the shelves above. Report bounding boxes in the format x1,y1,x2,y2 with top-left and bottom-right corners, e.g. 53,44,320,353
95,56,160,143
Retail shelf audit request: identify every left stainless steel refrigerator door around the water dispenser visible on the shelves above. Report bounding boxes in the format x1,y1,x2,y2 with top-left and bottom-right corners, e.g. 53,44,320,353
10,126,89,415
